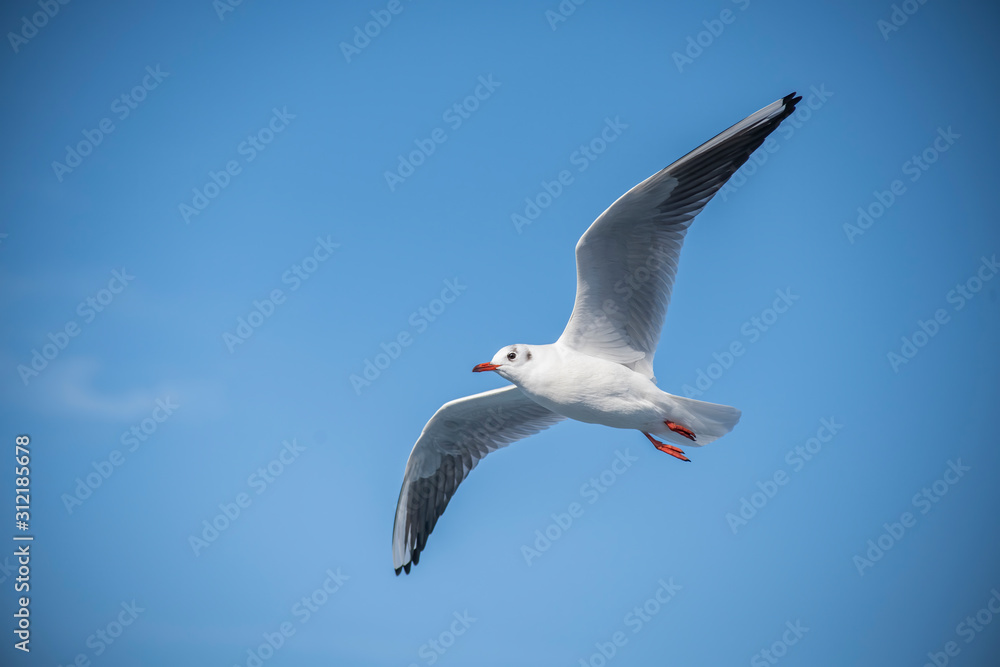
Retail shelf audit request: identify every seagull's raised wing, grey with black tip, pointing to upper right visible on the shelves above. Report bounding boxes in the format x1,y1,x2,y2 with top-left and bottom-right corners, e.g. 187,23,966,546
558,93,802,378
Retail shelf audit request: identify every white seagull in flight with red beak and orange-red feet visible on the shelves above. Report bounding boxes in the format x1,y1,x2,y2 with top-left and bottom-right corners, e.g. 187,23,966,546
392,93,802,575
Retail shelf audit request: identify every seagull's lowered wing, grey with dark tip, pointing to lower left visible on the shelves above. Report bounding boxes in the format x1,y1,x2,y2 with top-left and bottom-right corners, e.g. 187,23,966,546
392,386,563,574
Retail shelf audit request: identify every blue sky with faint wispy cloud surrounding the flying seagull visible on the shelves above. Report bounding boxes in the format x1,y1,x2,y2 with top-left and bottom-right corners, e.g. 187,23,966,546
0,0,1000,667
